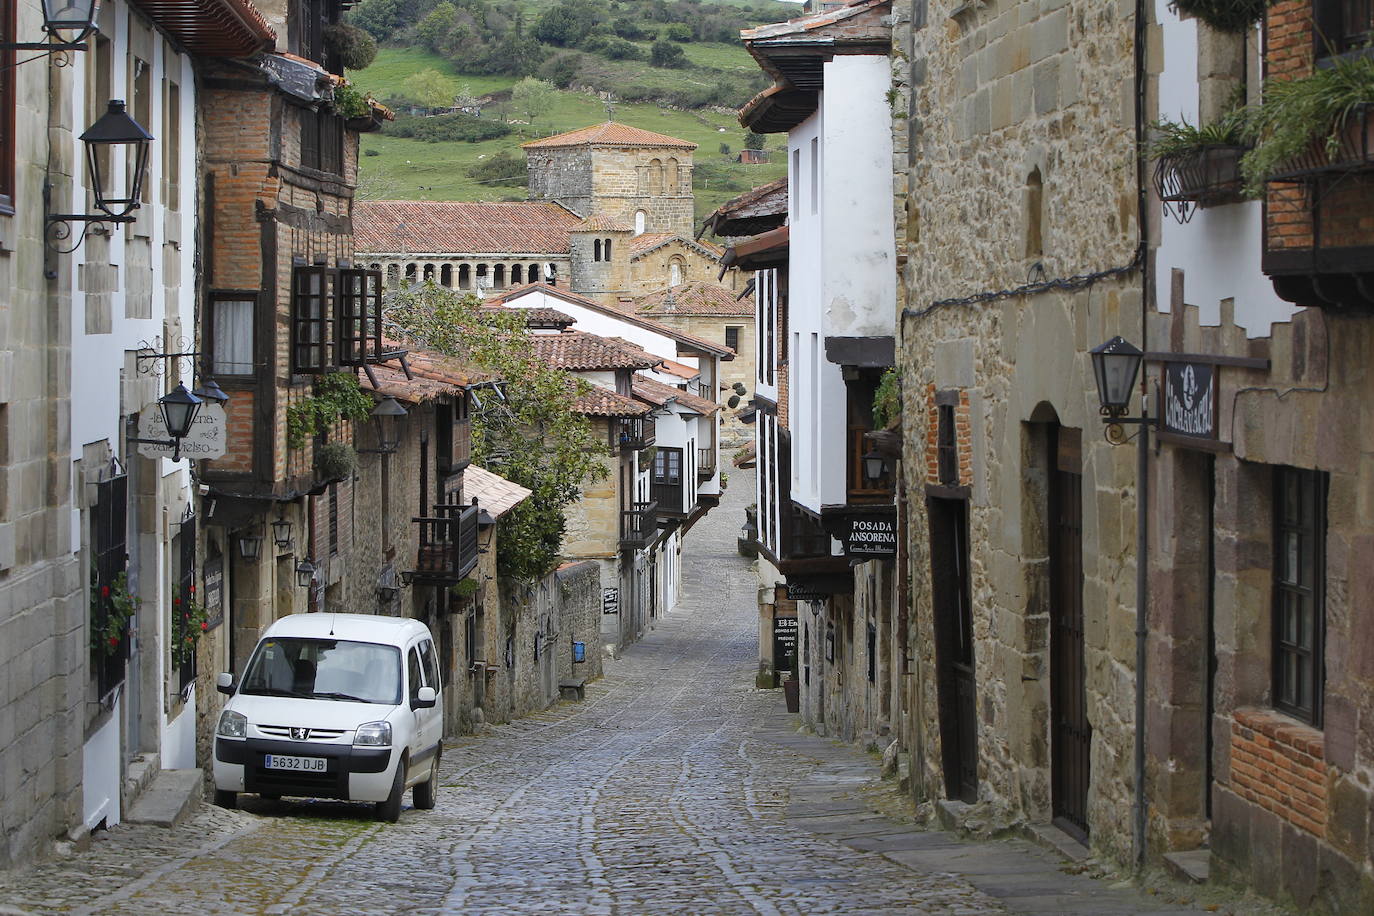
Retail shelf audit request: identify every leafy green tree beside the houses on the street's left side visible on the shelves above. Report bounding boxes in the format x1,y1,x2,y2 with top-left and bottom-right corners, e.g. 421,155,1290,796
385,282,609,582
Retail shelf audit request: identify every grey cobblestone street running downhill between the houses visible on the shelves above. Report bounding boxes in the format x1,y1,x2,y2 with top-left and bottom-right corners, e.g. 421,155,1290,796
0,474,1231,913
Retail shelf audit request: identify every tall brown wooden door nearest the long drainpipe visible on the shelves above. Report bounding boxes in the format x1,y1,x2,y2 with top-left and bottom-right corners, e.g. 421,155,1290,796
1050,428,1092,839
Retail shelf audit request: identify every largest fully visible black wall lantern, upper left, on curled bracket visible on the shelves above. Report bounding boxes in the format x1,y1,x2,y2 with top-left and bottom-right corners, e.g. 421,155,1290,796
44,99,153,253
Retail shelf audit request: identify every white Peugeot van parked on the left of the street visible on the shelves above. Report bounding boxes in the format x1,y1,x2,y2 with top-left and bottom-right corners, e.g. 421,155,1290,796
214,614,444,821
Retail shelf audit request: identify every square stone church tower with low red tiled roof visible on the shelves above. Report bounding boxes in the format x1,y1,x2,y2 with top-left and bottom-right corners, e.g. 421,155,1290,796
522,121,697,238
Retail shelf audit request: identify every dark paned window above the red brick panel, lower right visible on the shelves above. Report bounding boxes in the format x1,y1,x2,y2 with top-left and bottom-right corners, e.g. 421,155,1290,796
1271,467,1327,728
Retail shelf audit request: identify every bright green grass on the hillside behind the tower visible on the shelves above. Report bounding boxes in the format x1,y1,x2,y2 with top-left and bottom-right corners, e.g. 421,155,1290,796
350,45,786,220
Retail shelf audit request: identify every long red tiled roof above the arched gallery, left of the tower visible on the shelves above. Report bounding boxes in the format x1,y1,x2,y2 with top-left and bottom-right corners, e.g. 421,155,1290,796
353,201,581,257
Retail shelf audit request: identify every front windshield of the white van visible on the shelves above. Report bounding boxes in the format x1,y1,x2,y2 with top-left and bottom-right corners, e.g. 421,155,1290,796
239,637,401,706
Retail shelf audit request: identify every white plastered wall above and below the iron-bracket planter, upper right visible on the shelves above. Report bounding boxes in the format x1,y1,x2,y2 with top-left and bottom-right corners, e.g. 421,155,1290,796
1154,0,1297,338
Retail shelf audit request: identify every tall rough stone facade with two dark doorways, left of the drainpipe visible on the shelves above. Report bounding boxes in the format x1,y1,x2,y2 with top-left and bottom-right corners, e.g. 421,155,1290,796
893,0,1142,858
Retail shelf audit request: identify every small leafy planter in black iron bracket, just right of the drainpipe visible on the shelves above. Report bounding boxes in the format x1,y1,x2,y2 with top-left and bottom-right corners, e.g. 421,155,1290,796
1149,107,1249,221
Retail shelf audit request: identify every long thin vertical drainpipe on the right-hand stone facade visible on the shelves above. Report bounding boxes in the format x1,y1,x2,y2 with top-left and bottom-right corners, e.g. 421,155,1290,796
1134,0,1151,869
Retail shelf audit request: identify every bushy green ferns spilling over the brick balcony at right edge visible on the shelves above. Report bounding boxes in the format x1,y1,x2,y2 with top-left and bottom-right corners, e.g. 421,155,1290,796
1241,56,1374,196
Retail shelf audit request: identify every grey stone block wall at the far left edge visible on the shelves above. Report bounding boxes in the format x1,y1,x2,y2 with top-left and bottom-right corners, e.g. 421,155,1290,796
0,8,89,868
